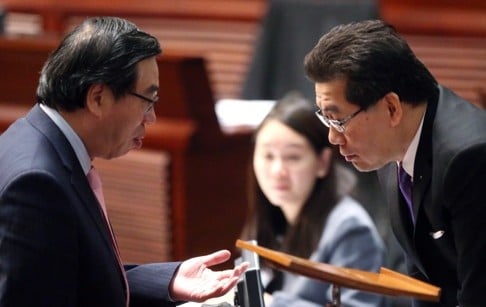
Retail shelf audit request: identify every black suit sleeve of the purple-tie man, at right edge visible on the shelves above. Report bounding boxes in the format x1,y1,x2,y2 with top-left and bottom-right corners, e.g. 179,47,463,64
443,145,486,306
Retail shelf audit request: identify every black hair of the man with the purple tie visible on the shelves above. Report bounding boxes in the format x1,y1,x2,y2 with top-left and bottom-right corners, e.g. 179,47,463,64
304,20,439,109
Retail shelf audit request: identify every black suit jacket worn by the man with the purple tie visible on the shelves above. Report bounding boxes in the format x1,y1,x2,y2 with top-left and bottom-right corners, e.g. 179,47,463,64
378,87,486,306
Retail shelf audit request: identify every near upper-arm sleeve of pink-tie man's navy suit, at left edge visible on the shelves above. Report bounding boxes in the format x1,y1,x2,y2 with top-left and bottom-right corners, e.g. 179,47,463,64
0,171,77,306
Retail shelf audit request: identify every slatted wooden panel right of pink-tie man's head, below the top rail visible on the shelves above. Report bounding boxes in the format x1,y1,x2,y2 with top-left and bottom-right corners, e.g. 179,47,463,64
69,17,259,100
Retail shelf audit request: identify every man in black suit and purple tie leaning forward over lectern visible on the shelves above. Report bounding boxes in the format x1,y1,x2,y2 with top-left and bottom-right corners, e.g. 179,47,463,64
304,20,486,306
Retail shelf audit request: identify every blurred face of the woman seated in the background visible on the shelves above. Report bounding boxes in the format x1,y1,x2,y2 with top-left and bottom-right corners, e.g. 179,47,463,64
253,120,328,222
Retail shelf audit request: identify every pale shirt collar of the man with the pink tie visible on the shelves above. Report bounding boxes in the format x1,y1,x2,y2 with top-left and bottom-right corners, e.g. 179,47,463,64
40,104,91,174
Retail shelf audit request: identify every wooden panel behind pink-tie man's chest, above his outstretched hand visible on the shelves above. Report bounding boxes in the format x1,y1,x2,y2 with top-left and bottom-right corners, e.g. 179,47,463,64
94,150,172,263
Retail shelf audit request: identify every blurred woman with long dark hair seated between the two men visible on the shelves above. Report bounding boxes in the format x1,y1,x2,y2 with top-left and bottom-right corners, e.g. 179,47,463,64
242,94,384,307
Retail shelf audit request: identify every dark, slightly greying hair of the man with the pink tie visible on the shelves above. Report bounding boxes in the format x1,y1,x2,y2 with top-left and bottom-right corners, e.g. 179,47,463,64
37,17,162,111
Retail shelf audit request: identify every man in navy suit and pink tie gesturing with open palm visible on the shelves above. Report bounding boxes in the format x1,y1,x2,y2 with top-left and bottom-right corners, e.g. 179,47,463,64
0,17,247,307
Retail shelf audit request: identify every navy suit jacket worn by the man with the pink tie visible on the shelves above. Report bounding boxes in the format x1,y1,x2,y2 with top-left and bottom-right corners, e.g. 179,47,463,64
0,106,178,307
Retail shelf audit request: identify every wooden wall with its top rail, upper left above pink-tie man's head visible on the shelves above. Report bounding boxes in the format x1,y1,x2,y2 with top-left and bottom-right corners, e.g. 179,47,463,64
3,0,266,99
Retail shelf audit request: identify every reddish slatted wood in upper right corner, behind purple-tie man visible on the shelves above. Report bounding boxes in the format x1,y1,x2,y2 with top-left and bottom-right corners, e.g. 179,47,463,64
379,0,486,108
